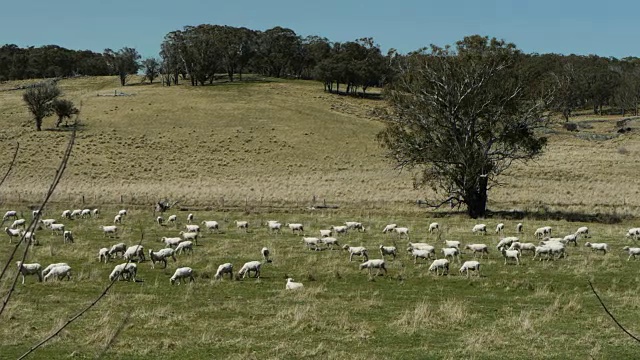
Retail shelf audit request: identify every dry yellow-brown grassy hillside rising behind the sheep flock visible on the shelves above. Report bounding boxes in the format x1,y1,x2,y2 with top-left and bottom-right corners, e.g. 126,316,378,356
0,77,640,215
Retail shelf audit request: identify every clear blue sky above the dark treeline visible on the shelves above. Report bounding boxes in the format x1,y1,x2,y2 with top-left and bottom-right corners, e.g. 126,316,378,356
0,0,640,58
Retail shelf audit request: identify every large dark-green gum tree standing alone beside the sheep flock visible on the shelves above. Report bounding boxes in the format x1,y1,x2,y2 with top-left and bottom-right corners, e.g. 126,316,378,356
378,35,548,218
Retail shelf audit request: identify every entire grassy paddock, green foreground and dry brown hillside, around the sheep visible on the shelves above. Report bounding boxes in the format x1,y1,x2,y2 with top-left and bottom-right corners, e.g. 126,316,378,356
0,78,640,359
